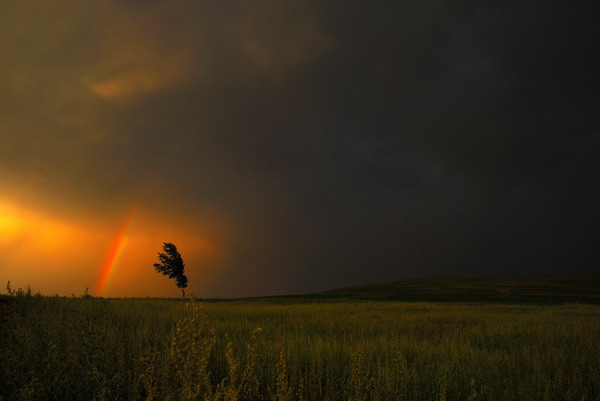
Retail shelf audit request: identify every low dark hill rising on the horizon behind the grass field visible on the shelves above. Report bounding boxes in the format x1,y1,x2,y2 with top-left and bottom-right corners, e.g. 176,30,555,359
312,275,600,304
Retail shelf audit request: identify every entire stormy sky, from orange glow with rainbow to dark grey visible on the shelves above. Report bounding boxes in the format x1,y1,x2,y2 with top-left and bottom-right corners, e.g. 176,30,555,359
0,0,600,297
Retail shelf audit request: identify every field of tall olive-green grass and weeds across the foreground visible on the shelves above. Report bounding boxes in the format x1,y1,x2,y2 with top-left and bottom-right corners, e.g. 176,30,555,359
0,295,600,401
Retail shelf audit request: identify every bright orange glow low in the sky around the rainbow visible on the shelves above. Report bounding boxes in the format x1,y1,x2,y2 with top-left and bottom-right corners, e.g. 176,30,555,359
0,200,221,297
